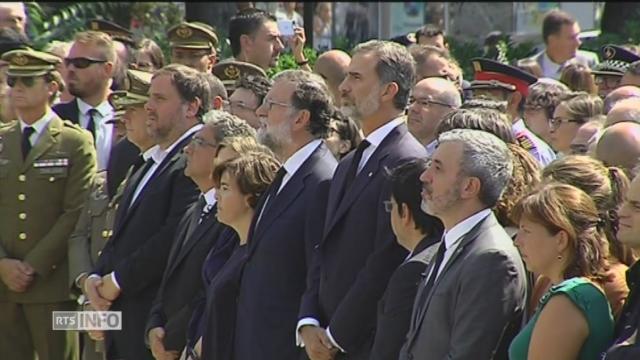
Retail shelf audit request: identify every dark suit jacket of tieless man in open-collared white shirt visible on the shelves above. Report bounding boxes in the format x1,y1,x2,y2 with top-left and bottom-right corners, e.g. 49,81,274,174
94,136,200,359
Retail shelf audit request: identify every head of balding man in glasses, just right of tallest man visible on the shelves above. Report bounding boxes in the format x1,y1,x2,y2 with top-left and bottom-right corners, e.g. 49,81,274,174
407,77,462,155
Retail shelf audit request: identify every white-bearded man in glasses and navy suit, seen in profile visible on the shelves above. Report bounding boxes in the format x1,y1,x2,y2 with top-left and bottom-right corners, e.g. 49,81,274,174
233,70,338,360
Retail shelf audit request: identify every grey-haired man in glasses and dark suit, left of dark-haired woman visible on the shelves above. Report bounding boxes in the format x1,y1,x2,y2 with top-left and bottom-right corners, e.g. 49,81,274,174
145,111,255,359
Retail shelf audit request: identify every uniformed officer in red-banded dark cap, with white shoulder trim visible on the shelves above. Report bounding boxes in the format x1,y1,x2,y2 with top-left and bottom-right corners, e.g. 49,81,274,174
470,58,556,166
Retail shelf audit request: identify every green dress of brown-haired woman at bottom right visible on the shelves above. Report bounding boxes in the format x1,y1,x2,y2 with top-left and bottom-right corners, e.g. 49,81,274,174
509,278,614,360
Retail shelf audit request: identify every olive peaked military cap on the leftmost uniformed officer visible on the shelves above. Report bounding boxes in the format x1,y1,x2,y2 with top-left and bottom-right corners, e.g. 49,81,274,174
2,49,62,77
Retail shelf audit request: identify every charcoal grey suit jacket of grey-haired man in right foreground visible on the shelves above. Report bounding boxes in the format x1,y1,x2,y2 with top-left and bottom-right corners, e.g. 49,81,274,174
400,213,527,360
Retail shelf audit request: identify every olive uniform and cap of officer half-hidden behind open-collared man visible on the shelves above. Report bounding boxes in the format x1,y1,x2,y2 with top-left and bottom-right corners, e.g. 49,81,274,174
68,70,152,360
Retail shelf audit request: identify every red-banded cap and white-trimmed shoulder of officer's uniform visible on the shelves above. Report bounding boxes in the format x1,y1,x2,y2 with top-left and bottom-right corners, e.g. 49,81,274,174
469,58,556,167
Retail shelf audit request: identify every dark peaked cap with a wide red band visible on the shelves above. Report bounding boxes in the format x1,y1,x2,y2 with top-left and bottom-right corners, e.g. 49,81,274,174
469,58,538,96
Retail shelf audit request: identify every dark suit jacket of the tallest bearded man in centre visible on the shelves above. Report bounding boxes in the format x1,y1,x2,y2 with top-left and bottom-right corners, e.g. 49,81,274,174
299,124,427,358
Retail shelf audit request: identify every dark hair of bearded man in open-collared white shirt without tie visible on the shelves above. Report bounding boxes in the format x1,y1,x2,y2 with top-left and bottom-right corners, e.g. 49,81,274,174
153,64,211,119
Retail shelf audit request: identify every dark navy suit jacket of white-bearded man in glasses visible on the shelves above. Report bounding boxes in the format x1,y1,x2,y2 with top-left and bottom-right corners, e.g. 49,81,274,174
234,143,338,360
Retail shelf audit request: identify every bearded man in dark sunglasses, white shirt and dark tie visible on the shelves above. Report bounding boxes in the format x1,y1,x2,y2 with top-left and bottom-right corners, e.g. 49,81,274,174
53,31,139,197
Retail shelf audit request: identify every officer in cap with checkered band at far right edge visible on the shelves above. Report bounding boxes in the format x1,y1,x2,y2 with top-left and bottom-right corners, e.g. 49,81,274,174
591,44,640,99
